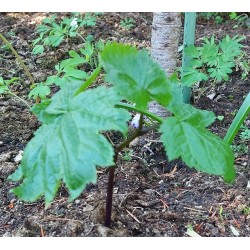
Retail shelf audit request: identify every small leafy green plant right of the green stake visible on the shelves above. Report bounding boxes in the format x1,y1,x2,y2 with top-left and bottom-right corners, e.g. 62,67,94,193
181,35,248,86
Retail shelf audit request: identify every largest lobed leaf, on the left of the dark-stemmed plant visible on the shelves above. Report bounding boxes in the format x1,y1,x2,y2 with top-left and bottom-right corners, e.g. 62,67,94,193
10,84,130,204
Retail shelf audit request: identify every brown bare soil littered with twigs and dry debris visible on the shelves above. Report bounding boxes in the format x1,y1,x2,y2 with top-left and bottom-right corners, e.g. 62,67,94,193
0,13,250,237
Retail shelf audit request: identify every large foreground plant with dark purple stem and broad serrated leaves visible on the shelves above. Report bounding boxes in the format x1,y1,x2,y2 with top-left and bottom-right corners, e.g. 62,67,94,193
9,43,235,226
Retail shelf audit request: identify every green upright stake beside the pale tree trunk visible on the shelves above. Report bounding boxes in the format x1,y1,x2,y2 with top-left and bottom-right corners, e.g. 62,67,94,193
182,12,196,103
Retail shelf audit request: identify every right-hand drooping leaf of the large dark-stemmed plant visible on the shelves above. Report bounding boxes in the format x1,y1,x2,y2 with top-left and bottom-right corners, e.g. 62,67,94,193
160,104,235,182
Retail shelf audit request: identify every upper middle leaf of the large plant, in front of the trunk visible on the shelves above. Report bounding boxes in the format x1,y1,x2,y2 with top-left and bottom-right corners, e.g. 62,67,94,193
101,43,172,110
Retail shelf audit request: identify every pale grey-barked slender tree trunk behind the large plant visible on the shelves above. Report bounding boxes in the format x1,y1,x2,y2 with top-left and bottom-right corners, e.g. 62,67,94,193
149,12,181,117
